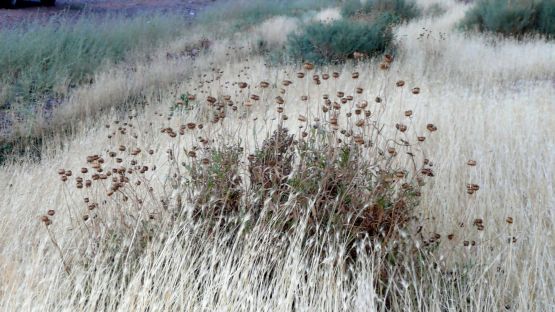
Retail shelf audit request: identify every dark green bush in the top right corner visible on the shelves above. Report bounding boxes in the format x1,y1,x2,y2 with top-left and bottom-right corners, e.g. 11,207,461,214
462,0,555,37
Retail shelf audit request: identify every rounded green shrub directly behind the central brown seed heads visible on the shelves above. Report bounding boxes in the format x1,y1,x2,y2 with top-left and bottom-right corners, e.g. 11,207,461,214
287,14,394,64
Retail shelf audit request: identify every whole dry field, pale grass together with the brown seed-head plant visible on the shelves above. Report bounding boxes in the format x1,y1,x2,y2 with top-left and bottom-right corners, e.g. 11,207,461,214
0,1,555,311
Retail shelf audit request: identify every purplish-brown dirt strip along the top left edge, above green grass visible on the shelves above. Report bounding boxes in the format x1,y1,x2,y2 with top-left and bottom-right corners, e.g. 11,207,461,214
0,0,217,27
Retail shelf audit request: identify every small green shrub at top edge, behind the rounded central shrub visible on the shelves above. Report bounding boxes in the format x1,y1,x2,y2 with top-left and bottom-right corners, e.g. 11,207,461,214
342,0,420,20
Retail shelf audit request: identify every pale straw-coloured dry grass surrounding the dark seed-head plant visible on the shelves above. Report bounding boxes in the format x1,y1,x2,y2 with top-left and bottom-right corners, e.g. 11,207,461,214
0,1,555,311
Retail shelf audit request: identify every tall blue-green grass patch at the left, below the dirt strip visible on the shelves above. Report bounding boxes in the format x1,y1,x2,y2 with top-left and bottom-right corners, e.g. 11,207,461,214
0,15,186,114
